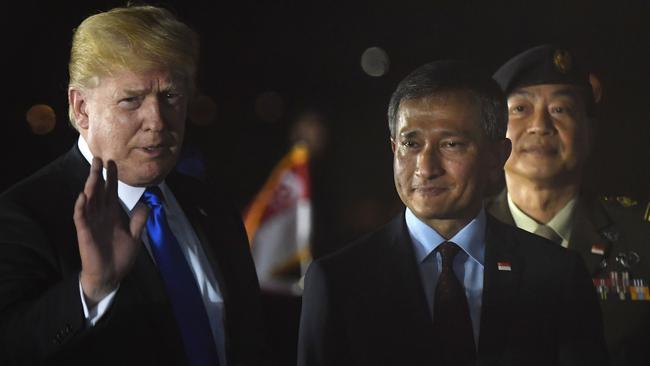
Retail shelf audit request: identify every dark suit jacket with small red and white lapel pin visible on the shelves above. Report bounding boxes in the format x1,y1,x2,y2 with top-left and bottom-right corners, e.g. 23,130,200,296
298,215,606,366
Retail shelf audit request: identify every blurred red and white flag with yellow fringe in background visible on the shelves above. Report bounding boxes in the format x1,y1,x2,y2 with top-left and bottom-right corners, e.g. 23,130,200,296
244,144,311,294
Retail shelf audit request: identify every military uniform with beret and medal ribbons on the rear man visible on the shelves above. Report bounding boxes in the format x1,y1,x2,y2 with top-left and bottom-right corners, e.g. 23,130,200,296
486,45,650,366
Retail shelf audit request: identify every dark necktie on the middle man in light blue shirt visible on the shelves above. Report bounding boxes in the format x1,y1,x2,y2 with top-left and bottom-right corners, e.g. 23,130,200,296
433,242,476,366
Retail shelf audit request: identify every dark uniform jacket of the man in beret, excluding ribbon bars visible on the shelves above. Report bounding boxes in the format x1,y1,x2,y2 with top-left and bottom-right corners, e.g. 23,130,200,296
487,191,650,366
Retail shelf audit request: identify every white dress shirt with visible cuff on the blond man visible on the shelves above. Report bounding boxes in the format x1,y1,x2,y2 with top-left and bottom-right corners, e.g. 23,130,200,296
78,135,227,366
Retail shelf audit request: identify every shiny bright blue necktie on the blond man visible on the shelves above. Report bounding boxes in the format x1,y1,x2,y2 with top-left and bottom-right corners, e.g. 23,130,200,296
142,187,219,366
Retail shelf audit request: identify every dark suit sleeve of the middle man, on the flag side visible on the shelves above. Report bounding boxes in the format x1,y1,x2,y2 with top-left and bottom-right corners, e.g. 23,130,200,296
298,261,352,366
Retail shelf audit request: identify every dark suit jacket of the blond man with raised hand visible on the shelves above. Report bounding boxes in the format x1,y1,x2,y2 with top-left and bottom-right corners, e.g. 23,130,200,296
0,146,262,365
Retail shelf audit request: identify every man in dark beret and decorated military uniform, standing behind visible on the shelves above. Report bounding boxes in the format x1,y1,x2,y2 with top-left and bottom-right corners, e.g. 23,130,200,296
487,45,650,365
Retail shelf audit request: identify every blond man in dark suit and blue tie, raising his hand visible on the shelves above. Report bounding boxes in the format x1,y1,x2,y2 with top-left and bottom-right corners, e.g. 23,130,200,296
0,6,262,366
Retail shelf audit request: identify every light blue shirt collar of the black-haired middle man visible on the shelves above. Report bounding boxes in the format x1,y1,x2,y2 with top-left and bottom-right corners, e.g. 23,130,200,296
405,208,487,265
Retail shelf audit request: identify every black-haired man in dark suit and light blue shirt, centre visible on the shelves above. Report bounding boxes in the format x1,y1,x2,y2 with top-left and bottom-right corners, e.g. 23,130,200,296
298,61,607,366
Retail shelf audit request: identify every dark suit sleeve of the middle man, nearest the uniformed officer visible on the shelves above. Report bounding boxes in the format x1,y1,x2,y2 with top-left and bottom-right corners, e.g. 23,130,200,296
558,252,609,366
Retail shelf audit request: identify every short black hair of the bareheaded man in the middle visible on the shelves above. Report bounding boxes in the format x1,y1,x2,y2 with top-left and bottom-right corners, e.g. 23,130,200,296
388,60,508,141
